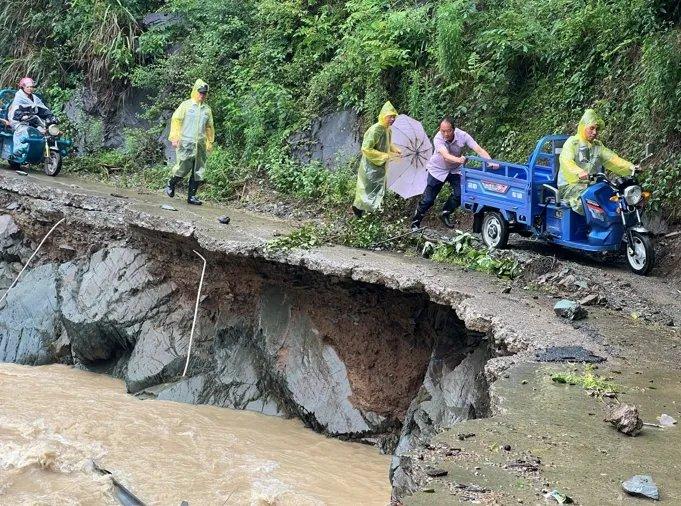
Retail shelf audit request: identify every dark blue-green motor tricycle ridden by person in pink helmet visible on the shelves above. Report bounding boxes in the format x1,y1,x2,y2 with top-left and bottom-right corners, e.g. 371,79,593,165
0,89,71,176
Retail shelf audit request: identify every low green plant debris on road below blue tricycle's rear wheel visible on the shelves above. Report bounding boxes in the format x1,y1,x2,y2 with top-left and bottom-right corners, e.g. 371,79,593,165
430,230,522,279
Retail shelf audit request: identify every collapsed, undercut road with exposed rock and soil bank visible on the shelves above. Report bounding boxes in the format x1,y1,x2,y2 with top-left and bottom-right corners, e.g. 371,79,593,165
0,171,681,504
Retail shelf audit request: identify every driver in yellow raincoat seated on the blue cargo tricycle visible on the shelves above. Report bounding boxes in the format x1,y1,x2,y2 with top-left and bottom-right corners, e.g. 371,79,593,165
558,109,636,215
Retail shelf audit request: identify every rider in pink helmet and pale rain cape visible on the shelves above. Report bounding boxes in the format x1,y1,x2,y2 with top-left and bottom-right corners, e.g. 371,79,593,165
7,77,57,158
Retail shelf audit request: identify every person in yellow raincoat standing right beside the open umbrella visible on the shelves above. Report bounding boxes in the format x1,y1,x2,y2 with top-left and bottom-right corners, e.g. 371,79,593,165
352,102,401,218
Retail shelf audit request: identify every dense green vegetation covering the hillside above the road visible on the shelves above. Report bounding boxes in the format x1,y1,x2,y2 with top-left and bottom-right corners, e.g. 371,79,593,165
0,0,681,218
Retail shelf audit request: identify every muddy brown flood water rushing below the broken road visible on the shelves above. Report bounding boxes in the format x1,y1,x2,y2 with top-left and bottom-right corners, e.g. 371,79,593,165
0,364,390,506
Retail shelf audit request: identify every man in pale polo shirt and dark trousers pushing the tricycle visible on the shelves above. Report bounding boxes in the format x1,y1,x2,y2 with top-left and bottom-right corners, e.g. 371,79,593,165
411,118,497,230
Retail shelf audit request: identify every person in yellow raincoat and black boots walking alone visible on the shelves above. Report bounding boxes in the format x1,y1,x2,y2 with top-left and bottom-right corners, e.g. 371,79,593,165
165,79,215,206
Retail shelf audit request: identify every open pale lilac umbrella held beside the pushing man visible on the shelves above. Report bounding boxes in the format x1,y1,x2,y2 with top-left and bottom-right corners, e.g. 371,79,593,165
387,114,433,199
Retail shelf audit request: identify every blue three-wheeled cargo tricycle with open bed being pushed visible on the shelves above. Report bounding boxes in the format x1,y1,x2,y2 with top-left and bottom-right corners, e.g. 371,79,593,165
461,135,655,275
